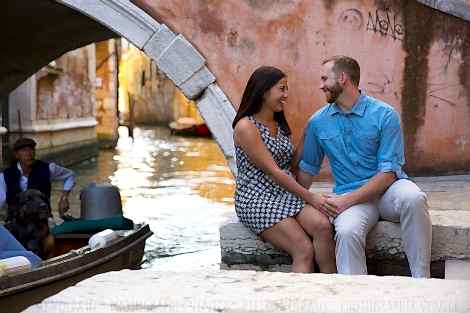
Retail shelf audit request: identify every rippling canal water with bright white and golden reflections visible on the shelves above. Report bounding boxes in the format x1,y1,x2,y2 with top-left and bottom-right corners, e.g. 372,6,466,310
64,127,236,271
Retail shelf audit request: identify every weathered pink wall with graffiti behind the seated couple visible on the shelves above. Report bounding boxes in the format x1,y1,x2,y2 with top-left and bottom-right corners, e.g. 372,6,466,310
133,0,470,174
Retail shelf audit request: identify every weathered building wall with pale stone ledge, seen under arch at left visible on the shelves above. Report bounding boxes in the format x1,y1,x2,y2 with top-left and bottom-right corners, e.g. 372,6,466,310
9,44,98,165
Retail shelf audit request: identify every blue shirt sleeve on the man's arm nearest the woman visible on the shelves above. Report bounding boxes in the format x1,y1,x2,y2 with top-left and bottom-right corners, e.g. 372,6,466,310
299,121,325,176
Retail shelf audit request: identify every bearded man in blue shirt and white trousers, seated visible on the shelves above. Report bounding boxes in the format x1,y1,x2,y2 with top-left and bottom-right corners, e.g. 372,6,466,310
298,56,431,277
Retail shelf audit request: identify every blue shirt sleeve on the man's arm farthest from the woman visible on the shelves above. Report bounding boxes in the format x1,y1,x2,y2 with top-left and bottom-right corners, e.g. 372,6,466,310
377,110,407,178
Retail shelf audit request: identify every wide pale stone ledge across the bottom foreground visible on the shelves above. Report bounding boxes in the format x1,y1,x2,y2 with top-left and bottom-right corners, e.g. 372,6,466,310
24,270,470,313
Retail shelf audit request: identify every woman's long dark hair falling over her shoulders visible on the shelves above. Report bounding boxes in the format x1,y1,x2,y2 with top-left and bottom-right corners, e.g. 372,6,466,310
232,66,291,135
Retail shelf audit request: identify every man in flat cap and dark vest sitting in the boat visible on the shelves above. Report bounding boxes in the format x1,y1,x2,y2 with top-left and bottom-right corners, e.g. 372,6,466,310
0,138,75,223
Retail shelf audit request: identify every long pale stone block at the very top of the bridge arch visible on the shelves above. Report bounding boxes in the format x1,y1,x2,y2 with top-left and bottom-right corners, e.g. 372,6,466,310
58,0,160,49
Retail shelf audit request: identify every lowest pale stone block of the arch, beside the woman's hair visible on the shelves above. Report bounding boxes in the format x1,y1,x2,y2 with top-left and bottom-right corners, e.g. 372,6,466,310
196,84,236,159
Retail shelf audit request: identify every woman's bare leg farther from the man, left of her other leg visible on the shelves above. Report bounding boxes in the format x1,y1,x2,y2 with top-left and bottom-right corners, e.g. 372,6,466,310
261,217,314,273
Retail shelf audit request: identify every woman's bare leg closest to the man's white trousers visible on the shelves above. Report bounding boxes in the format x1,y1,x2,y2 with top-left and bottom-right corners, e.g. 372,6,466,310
296,204,336,273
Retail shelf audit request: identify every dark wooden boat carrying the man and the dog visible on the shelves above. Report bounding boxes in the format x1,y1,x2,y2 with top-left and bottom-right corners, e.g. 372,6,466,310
0,224,153,312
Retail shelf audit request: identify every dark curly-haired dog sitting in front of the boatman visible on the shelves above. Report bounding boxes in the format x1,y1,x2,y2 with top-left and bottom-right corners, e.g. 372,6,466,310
5,189,54,260
